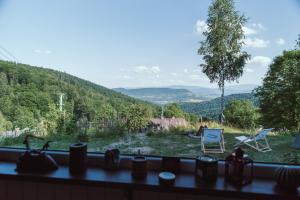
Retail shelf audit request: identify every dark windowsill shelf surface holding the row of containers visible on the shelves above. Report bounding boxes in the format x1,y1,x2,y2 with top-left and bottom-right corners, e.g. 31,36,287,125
0,162,300,199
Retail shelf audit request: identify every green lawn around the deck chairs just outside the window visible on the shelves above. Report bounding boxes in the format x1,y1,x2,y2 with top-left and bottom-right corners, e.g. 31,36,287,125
0,124,300,164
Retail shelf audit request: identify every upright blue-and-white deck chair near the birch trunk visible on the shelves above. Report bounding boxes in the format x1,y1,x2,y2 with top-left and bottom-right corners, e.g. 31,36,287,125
201,128,225,153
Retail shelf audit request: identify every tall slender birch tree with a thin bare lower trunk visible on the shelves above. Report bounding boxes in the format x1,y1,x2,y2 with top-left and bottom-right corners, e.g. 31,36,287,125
198,0,250,122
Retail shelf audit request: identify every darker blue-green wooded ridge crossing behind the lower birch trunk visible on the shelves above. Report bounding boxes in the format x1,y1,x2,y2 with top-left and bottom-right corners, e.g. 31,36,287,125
179,93,258,120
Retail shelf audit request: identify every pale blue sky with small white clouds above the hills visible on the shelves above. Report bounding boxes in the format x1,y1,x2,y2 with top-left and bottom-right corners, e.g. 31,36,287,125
0,0,300,88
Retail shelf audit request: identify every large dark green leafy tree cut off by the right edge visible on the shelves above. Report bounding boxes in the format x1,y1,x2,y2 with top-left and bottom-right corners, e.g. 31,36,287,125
256,50,300,130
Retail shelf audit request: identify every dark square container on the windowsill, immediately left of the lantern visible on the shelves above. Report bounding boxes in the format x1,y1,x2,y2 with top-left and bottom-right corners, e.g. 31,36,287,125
195,155,218,182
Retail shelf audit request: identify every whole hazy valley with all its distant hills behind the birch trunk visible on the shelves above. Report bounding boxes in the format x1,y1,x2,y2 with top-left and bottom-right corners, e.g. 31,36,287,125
113,85,258,120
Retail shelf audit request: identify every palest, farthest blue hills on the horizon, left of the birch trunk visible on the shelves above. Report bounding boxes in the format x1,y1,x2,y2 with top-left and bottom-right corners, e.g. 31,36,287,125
114,88,204,104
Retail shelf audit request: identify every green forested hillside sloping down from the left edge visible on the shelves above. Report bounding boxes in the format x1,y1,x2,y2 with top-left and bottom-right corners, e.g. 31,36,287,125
0,61,156,133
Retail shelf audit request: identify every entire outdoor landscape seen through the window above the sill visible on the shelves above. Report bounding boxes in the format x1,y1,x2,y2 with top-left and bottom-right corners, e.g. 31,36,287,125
0,0,300,164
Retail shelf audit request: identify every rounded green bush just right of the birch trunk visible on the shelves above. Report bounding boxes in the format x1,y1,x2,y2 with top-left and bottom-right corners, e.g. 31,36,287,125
224,100,259,129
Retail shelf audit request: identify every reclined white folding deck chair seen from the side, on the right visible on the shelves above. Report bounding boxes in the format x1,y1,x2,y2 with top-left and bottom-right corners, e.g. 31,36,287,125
234,128,273,152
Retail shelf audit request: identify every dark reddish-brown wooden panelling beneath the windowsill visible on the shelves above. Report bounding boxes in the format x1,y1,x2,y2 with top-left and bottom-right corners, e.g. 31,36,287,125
0,180,248,200
